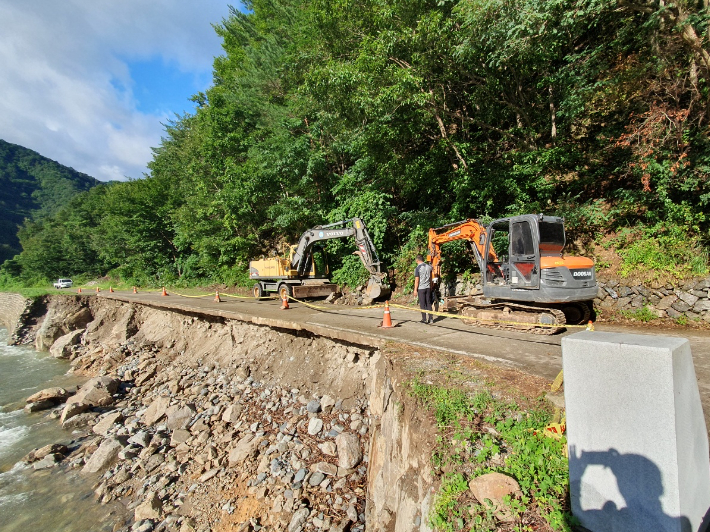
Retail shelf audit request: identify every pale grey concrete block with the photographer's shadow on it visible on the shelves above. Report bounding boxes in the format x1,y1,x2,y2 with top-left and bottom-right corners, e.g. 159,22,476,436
562,331,710,532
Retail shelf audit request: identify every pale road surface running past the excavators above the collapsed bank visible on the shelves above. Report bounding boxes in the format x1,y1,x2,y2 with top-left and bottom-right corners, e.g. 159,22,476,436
98,292,710,429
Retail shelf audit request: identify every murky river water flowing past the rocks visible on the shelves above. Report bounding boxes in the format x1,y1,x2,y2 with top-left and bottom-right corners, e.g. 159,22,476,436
0,327,123,532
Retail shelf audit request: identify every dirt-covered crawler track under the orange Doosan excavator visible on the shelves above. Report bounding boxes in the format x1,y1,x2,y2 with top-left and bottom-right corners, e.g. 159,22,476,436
460,302,567,335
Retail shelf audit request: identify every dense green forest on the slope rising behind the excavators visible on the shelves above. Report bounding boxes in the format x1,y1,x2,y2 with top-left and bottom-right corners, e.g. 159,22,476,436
0,0,710,290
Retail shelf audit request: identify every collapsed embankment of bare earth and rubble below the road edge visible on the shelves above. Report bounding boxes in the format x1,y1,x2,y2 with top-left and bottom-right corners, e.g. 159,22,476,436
8,296,444,532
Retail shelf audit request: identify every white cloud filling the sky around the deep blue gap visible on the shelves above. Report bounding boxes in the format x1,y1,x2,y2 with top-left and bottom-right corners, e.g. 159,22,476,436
0,0,228,180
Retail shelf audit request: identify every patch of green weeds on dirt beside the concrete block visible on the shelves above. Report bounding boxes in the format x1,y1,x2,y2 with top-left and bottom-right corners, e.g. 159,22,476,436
409,380,573,532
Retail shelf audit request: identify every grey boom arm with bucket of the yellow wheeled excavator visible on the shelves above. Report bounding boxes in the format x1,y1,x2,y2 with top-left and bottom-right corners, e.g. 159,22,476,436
291,218,386,299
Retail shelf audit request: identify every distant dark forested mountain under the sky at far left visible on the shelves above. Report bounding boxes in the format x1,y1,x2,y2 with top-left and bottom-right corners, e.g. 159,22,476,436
0,139,99,263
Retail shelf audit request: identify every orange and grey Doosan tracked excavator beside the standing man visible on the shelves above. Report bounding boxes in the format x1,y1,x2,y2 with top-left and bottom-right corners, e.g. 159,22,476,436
428,214,597,334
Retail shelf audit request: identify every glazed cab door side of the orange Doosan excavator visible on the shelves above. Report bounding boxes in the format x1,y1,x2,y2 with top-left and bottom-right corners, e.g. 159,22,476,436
484,215,540,297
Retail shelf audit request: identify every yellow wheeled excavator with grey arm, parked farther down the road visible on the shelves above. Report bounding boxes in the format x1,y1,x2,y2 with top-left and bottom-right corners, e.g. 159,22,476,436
249,218,390,299
